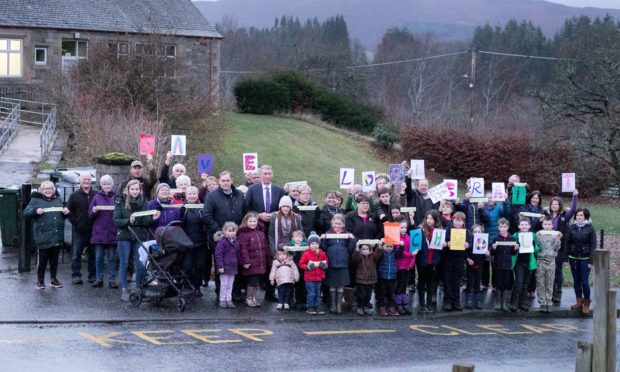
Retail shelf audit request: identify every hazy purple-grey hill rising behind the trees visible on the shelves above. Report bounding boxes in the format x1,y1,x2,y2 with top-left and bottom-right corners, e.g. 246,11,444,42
194,0,620,49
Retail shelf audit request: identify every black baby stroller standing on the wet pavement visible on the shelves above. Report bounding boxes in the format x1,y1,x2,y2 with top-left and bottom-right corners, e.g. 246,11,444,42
129,221,195,312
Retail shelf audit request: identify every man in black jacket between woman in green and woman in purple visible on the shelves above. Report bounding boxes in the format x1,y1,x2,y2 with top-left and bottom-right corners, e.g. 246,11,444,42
67,173,97,284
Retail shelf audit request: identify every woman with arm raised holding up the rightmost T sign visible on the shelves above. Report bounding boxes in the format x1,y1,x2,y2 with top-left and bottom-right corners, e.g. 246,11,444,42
544,189,579,306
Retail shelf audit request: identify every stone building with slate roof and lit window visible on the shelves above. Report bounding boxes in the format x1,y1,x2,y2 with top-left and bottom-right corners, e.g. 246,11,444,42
0,0,222,105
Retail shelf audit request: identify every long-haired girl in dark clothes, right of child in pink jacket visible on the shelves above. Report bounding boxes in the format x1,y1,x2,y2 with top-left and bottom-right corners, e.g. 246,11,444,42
416,209,442,313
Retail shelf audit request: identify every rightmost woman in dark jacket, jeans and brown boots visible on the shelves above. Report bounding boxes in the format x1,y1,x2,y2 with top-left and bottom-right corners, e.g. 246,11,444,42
568,208,596,314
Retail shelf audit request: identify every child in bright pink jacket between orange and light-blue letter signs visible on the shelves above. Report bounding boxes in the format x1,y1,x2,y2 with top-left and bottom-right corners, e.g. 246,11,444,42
394,219,418,315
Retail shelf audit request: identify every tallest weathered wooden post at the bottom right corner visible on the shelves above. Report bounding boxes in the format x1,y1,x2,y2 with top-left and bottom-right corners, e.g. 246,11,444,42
592,249,615,372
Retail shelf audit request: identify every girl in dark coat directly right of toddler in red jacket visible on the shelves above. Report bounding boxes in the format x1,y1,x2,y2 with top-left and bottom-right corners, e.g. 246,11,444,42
321,214,355,314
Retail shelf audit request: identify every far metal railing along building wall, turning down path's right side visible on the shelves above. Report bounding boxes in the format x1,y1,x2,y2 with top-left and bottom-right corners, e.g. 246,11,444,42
0,98,56,161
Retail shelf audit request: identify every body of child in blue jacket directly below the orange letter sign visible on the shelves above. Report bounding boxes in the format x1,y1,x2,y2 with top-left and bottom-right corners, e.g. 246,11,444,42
375,244,403,316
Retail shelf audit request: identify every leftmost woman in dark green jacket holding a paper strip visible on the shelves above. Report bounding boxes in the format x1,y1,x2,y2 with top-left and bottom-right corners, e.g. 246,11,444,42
24,181,69,289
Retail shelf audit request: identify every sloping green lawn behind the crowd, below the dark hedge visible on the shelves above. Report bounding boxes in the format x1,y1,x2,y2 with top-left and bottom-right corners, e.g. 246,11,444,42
214,113,388,198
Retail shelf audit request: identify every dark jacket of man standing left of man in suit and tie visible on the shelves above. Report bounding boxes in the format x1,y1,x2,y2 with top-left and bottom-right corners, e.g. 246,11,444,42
202,186,246,233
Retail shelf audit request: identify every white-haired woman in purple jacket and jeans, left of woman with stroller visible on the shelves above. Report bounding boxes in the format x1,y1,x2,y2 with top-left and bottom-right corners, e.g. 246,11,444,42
88,174,118,288
